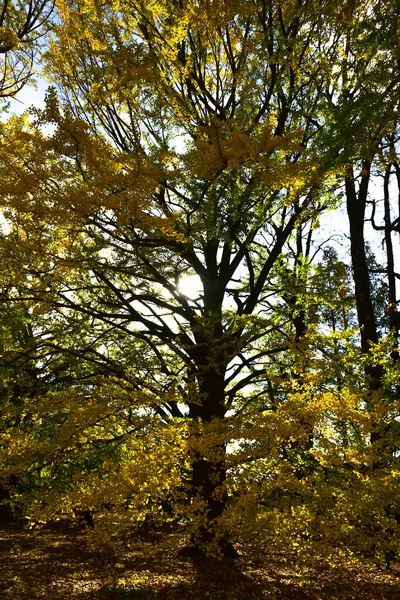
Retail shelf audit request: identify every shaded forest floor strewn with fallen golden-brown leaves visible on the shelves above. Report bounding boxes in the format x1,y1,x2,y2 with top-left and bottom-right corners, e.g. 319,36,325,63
0,521,400,600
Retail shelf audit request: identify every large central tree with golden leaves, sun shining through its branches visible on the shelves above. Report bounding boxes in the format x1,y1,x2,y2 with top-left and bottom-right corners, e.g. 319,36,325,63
0,0,397,556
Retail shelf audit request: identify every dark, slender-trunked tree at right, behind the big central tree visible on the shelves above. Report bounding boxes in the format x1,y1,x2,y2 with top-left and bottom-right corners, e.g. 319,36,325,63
332,6,400,565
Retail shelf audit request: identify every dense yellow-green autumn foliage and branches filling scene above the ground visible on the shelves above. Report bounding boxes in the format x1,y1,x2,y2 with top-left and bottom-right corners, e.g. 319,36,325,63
0,0,400,560
